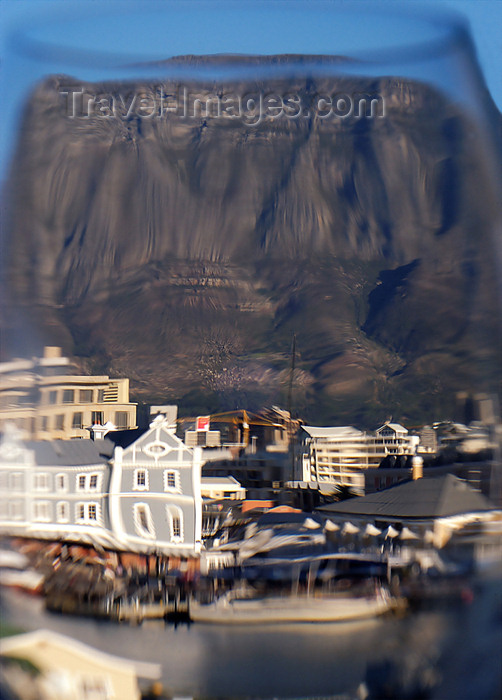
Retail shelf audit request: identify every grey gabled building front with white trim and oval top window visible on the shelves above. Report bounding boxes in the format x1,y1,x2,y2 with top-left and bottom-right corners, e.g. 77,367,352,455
106,415,202,556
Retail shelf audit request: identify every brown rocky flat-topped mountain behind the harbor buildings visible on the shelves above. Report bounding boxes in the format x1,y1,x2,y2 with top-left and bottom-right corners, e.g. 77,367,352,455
5,63,501,424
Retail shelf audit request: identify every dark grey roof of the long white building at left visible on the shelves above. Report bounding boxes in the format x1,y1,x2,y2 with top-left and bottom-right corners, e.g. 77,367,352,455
25,439,107,467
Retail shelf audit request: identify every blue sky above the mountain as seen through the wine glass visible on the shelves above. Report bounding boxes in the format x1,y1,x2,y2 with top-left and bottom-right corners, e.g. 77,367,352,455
0,0,498,178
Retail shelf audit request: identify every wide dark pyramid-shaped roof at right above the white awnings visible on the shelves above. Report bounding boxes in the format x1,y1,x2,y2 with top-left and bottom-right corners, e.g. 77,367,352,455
317,474,495,518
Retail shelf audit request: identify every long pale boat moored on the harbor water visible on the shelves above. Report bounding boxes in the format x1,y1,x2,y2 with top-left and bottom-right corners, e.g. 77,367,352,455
190,588,394,624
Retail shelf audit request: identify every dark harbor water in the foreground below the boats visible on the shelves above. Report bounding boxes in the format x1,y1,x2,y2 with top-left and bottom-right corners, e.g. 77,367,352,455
1,574,502,700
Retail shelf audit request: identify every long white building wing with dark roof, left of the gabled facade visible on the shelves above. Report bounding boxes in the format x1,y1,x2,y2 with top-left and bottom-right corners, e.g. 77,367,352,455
0,425,114,546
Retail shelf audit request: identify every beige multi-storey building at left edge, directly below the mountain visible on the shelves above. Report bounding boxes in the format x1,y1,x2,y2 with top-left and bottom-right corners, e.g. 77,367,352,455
0,347,136,440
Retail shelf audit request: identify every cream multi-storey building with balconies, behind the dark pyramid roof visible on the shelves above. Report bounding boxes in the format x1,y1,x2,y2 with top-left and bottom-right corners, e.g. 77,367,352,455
300,422,419,494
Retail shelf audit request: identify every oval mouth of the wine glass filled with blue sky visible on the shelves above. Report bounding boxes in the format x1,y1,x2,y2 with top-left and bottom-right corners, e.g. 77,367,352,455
9,0,467,70
